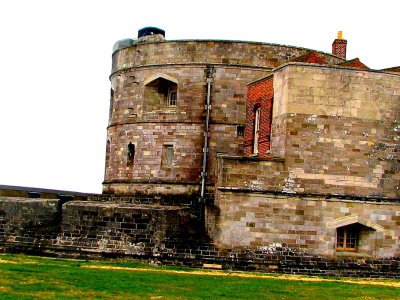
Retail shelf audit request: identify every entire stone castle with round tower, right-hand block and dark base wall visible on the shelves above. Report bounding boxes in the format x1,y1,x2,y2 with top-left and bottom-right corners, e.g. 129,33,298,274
0,27,400,277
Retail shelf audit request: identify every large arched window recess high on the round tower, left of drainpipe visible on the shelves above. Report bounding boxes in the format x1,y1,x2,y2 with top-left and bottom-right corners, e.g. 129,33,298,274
143,74,178,112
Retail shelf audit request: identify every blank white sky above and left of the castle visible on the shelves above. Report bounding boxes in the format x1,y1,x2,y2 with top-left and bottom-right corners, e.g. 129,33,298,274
0,0,400,193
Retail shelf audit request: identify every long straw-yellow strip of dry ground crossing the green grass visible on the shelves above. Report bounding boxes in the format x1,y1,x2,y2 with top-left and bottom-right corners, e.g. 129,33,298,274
82,265,400,288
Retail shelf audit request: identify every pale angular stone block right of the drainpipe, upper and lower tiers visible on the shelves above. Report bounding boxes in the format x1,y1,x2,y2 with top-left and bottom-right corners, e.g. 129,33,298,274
207,63,400,268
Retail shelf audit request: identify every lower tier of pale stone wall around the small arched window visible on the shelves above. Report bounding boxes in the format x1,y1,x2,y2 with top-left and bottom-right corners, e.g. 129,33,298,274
214,189,400,258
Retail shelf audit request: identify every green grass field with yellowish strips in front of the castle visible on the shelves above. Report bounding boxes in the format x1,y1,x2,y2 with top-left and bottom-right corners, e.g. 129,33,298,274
0,254,400,299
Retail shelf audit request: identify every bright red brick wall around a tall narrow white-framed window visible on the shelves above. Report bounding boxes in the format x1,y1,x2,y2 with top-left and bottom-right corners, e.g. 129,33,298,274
243,76,274,157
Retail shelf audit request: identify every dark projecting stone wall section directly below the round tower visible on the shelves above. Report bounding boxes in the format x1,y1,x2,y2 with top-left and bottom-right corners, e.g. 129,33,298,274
56,201,195,255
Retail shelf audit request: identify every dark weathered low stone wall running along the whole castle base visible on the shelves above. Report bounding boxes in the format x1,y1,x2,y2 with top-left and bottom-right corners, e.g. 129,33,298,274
0,191,400,278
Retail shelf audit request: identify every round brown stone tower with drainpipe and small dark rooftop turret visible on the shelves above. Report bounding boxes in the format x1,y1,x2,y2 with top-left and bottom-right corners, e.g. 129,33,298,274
103,27,344,195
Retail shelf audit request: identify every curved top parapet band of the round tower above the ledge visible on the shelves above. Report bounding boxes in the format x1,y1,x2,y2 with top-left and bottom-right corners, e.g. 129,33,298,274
112,40,344,73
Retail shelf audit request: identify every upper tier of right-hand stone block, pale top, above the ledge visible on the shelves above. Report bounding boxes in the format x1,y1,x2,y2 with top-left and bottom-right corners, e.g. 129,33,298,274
271,65,400,197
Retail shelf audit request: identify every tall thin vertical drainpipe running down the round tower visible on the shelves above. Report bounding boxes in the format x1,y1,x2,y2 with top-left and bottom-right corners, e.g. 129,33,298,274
200,65,214,220
